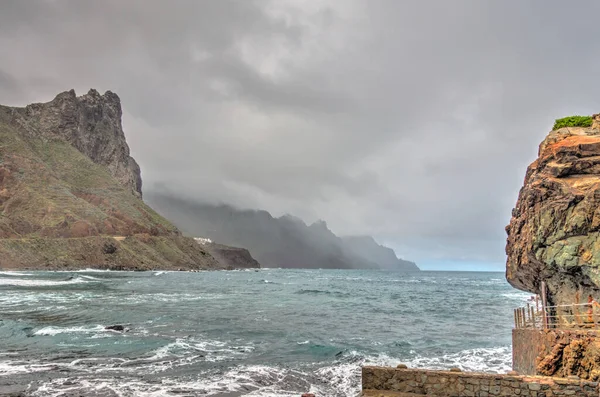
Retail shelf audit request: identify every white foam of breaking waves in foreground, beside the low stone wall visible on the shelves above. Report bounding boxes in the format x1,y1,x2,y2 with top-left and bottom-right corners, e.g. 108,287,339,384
23,346,510,397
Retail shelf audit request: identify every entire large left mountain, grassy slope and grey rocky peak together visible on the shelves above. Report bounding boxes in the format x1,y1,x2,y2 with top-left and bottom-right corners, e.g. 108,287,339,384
0,90,228,270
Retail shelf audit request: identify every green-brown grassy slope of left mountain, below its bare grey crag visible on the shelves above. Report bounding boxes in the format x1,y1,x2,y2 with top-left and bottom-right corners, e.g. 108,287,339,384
0,93,227,270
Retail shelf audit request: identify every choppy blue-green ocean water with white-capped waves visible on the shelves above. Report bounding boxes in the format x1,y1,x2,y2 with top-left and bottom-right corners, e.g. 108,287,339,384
0,269,529,397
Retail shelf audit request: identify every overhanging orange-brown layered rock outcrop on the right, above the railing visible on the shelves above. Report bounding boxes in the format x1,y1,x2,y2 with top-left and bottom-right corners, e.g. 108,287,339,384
506,123,600,304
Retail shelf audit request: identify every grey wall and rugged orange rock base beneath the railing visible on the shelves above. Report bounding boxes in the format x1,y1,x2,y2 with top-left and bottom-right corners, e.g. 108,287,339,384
513,329,600,381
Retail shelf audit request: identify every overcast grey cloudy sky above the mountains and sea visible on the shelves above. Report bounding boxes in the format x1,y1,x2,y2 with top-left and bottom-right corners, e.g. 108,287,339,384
0,0,600,270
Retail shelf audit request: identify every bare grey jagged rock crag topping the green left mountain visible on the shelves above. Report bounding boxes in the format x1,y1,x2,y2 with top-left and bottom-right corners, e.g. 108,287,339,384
12,89,142,197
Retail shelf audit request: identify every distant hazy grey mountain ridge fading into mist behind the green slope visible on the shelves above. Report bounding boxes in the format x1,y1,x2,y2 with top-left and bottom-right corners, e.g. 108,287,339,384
145,191,419,271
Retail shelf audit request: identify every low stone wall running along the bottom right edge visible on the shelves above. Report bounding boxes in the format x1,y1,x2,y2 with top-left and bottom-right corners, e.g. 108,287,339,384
362,367,600,397
